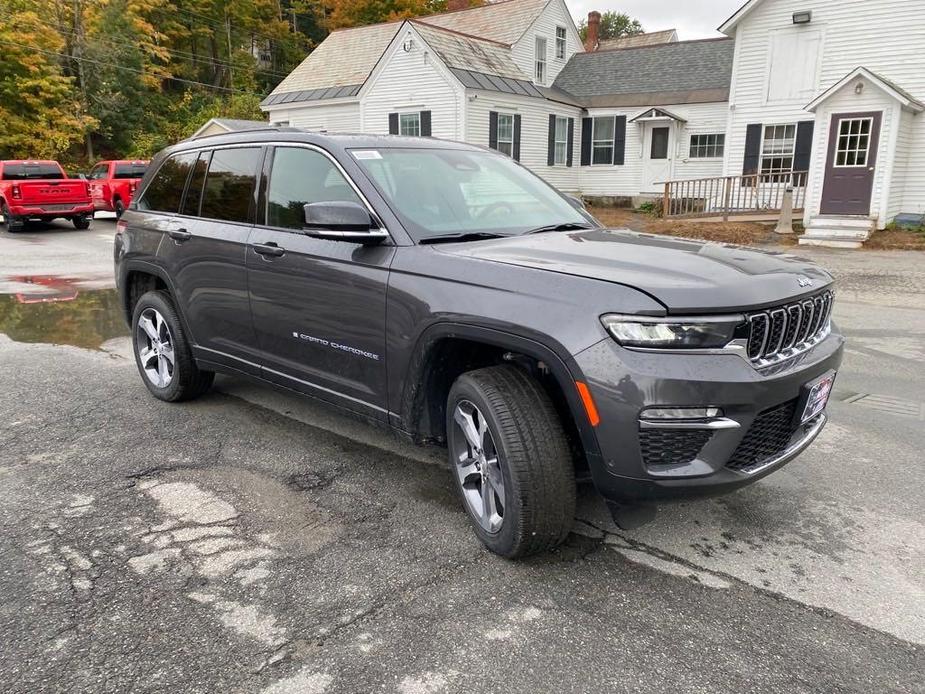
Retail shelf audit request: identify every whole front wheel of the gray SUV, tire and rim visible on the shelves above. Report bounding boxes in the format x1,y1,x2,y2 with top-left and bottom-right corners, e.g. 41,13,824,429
446,366,575,558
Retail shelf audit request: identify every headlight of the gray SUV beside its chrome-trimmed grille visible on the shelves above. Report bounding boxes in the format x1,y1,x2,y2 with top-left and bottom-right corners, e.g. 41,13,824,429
601,313,745,349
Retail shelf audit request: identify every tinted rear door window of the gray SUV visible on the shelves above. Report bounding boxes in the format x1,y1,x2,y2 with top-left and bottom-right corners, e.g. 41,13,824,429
200,147,261,224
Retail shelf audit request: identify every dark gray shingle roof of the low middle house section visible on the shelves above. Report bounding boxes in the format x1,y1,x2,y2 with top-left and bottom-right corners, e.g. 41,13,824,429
554,39,735,107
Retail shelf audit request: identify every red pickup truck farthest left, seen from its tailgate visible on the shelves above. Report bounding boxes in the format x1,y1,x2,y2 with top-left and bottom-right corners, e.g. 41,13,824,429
0,159,93,232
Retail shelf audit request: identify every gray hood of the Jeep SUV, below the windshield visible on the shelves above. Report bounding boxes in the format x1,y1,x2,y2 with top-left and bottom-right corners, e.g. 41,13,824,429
436,229,832,314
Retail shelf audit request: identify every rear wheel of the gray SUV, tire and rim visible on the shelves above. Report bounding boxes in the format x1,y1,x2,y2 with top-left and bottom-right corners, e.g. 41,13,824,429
132,291,215,402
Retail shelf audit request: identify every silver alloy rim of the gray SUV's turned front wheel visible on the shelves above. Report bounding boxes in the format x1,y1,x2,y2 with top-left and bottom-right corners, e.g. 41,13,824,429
451,400,505,534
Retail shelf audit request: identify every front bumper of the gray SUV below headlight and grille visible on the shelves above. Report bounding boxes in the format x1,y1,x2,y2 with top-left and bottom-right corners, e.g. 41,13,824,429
574,329,844,503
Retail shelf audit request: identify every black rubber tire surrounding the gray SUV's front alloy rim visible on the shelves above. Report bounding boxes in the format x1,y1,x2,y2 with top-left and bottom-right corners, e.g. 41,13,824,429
447,365,575,559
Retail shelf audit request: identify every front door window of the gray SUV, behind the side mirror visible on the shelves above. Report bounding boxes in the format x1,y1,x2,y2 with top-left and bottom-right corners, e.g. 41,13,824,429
267,147,363,230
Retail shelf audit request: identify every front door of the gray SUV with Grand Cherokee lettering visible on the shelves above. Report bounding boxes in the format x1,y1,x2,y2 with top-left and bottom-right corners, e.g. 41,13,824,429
247,146,394,419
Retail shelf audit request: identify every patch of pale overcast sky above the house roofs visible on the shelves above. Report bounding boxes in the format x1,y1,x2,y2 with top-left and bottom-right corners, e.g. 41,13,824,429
566,0,745,41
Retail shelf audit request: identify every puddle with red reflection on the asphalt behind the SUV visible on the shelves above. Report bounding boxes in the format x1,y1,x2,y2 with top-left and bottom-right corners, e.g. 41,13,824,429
0,275,129,349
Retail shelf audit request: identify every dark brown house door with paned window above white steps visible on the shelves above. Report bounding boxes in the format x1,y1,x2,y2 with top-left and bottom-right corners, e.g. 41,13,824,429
821,111,882,215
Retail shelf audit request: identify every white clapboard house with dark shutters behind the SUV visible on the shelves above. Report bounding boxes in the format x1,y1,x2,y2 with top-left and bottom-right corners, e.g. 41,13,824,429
262,0,925,246
